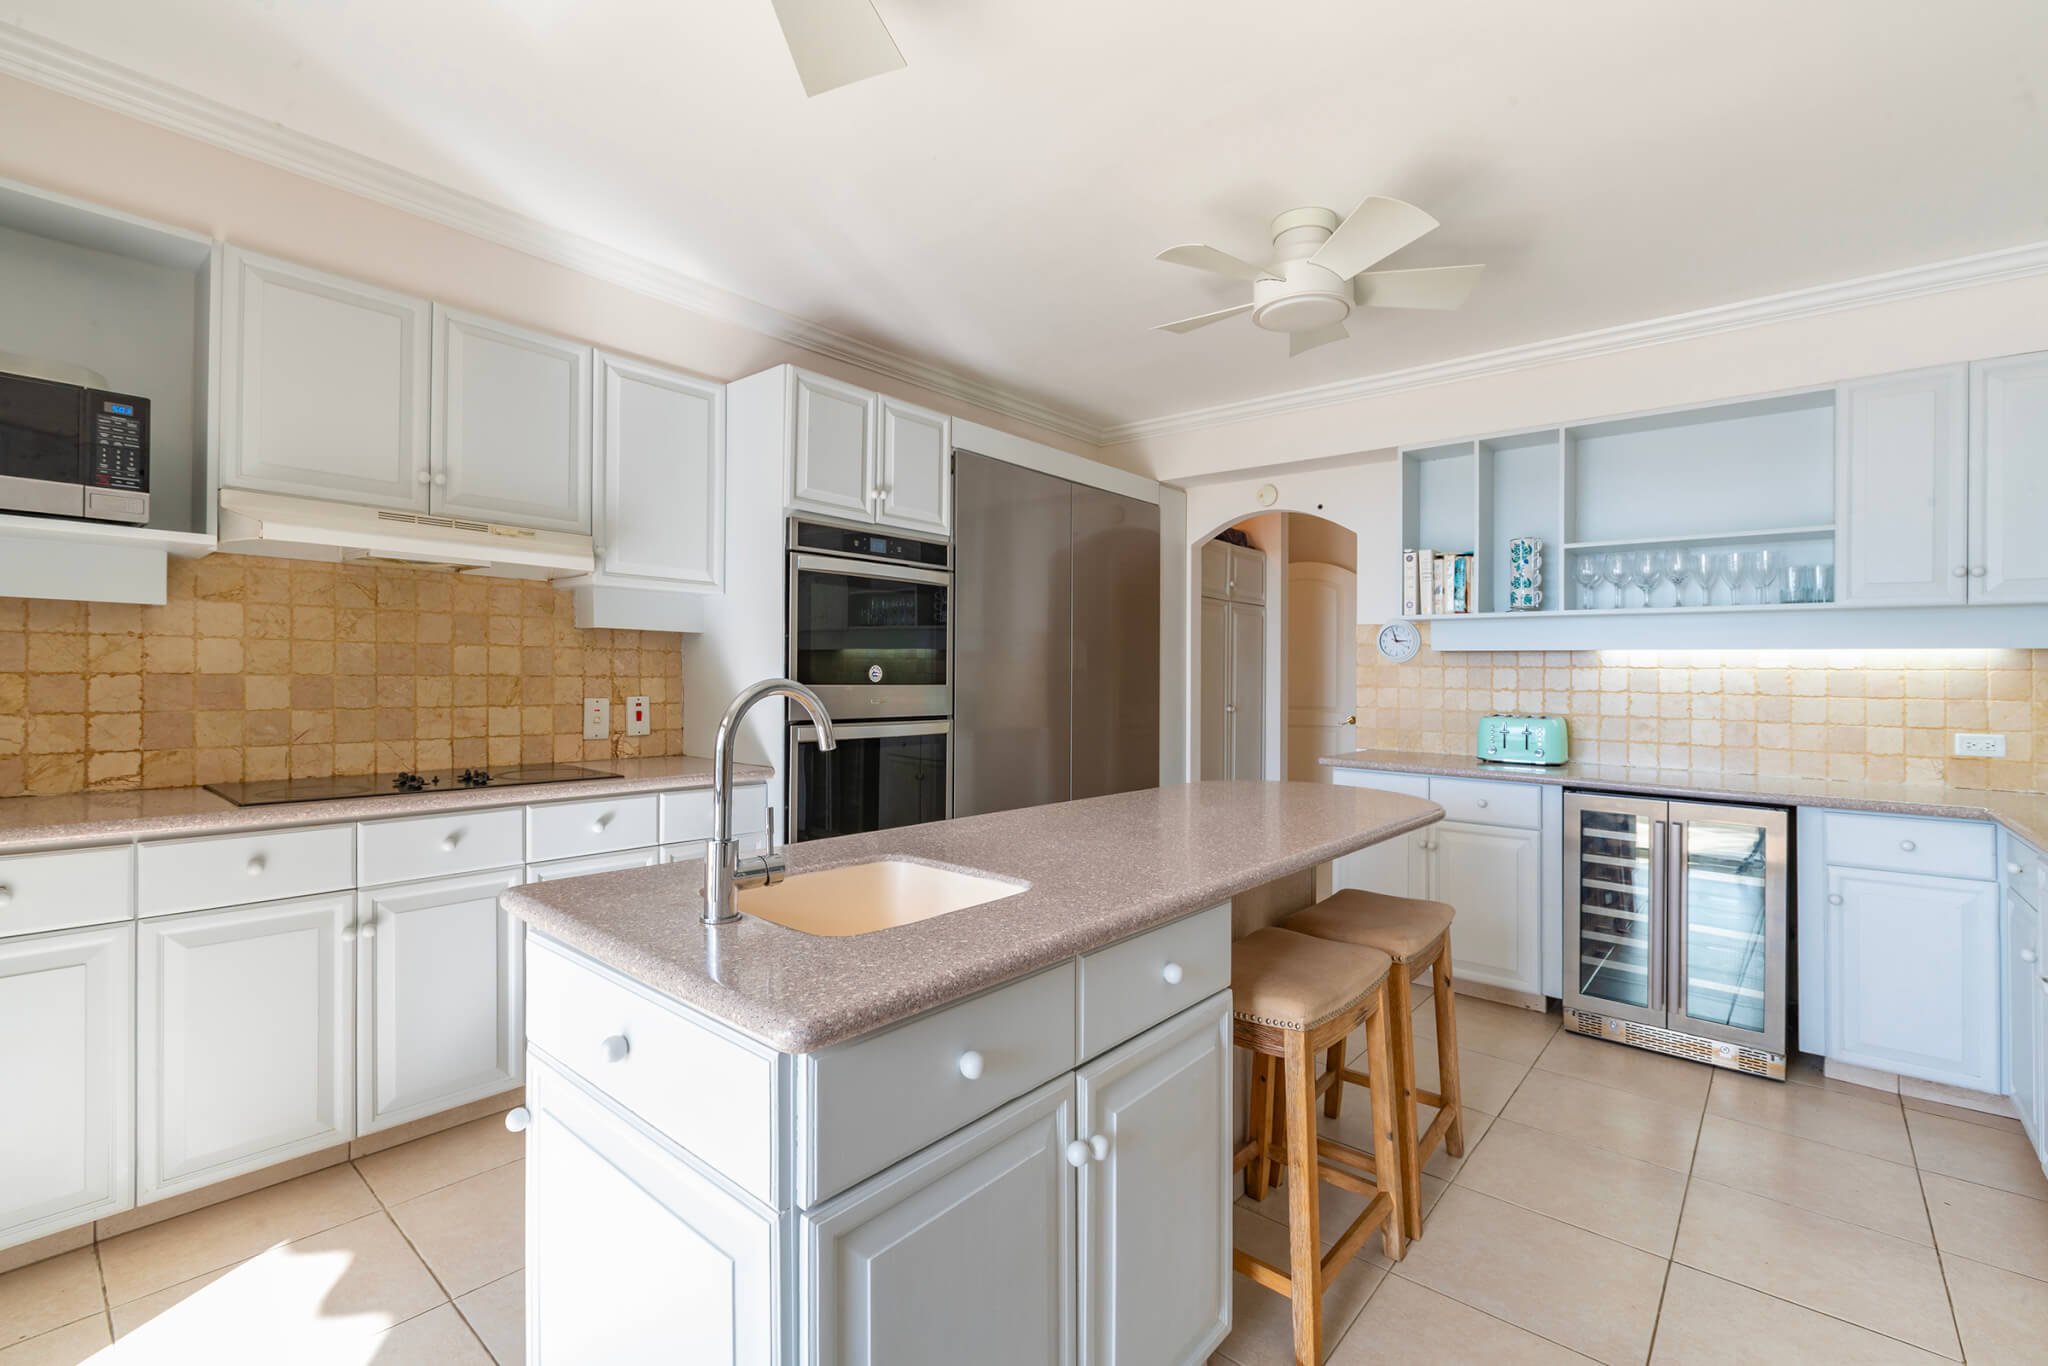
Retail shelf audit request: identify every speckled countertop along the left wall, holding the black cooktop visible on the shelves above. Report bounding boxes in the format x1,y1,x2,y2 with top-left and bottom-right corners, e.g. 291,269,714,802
0,756,774,852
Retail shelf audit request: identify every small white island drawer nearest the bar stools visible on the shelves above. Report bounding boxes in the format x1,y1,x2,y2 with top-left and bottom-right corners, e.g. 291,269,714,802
1079,901,1231,1061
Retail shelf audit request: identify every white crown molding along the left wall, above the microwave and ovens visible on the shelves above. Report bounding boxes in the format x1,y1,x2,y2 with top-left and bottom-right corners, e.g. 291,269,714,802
0,23,1102,444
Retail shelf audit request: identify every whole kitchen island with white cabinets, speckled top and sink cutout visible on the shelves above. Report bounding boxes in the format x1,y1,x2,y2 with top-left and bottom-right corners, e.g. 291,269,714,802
502,782,1442,1366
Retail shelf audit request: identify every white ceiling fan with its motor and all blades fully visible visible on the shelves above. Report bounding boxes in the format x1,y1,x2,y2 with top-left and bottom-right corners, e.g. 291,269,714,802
1153,195,1485,356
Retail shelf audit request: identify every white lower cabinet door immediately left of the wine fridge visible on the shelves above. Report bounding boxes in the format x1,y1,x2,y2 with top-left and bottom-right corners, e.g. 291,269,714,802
1413,821,1542,993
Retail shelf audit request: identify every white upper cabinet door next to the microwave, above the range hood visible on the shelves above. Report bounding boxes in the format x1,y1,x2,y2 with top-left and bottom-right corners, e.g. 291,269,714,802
221,246,432,512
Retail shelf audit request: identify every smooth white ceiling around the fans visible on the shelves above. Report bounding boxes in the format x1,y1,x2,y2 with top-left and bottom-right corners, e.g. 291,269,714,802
0,0,2048,436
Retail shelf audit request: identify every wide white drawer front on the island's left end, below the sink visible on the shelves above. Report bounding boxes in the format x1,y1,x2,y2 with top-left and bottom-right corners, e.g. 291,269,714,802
526,934,778,1206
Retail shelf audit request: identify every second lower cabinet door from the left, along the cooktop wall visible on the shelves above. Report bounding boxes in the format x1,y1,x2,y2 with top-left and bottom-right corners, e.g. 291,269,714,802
135,893,354,1204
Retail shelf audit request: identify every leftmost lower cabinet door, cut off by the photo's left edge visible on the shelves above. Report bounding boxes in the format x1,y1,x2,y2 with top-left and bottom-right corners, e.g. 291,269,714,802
0,924,135,1247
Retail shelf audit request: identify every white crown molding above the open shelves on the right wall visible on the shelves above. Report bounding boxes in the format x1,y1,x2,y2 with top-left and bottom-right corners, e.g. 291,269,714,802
1096,242,2048,446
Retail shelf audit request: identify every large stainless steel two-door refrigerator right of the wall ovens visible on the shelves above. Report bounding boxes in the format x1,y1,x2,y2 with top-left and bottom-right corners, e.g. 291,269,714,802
952,451,1159,815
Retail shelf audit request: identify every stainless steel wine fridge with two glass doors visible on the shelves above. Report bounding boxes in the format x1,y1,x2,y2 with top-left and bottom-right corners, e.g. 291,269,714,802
1565,793,1790,1081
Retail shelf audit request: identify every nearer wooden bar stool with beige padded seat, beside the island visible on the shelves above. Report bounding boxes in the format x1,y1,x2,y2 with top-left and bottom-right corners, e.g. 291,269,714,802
1231,930,1407,1366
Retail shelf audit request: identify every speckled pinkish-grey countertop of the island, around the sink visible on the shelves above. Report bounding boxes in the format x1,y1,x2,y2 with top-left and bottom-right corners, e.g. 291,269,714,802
500,782,1444,1053
